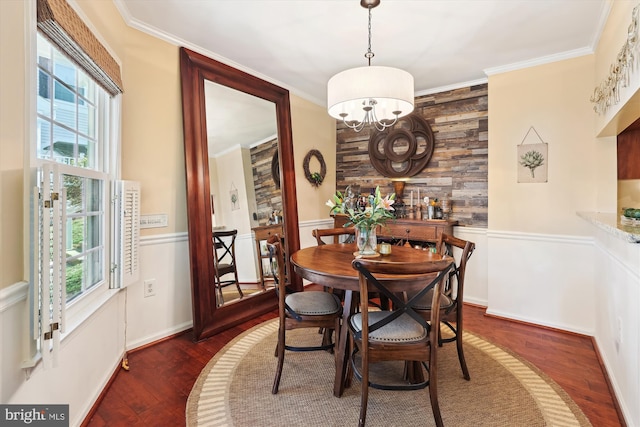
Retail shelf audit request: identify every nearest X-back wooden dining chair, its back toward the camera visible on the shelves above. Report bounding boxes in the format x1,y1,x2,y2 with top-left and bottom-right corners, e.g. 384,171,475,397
348,257,453,426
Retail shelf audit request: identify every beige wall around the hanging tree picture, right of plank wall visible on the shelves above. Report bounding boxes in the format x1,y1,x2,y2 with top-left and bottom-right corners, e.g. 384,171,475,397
489,55,616,235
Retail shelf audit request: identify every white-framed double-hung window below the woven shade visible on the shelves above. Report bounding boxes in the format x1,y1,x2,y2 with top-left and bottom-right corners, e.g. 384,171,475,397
35,34,111,302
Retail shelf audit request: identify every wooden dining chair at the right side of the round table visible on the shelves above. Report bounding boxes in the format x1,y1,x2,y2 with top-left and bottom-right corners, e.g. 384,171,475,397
415,234,476,381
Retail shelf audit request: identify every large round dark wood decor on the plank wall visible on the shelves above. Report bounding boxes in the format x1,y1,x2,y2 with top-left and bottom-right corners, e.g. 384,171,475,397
369,113,435,178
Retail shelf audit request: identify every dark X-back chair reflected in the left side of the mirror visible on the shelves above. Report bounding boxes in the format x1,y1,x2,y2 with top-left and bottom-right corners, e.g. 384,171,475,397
213,230,244,305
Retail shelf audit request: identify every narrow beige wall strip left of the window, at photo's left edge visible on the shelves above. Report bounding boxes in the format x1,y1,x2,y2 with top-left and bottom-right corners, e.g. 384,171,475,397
0,0,28,289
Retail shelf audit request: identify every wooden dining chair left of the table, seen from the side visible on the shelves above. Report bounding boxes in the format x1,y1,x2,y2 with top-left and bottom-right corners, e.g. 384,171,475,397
267,234,342,394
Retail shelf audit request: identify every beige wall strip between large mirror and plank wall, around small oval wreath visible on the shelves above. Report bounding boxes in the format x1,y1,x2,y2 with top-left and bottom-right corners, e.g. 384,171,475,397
291,95,336,221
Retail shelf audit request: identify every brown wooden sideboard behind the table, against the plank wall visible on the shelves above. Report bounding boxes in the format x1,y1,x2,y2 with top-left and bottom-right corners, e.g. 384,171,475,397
333,215,458,243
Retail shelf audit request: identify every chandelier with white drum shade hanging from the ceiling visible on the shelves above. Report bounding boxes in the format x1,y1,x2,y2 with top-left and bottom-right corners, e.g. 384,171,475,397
327,0,414,132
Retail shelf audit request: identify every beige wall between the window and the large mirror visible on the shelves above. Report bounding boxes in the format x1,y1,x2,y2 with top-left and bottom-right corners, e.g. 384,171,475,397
77,0,187,236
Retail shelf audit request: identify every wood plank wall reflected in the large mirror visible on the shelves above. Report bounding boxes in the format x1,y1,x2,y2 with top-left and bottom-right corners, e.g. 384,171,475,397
250,138,282,225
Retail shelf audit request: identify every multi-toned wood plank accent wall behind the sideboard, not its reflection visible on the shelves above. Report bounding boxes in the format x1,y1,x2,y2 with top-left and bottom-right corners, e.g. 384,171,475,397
336,84,489,231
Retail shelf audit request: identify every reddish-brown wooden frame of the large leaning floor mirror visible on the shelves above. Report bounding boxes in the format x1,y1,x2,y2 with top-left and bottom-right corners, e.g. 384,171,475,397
180,48,302,341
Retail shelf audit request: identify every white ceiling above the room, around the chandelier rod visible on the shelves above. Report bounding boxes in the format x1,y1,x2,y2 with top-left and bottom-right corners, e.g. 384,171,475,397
114,0,612,151
